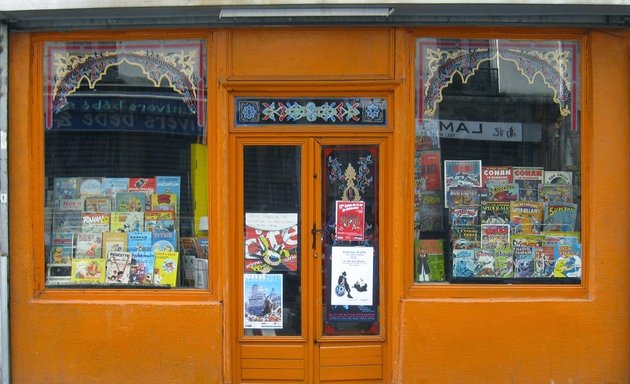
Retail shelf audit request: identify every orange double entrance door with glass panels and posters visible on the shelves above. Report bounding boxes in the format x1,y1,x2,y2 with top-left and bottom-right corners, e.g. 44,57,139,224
233,138,384,383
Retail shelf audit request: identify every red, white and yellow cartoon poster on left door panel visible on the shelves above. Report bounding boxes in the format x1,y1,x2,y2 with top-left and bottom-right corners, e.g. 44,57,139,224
245,213,298,273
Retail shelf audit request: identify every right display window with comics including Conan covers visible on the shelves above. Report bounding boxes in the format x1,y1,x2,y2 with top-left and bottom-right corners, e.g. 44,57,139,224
414,38,583,285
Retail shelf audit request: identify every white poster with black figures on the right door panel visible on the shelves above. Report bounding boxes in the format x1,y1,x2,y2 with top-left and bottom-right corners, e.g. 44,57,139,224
330,247,374,305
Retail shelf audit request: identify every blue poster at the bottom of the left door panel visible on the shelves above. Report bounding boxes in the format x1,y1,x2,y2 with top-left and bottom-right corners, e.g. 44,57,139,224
243,273,282,329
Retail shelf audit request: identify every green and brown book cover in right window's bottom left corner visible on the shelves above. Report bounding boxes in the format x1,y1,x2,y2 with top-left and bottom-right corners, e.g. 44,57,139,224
414,239,445,283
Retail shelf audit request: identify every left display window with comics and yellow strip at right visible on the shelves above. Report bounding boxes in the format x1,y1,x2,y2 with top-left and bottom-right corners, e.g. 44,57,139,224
42,39,209,289
